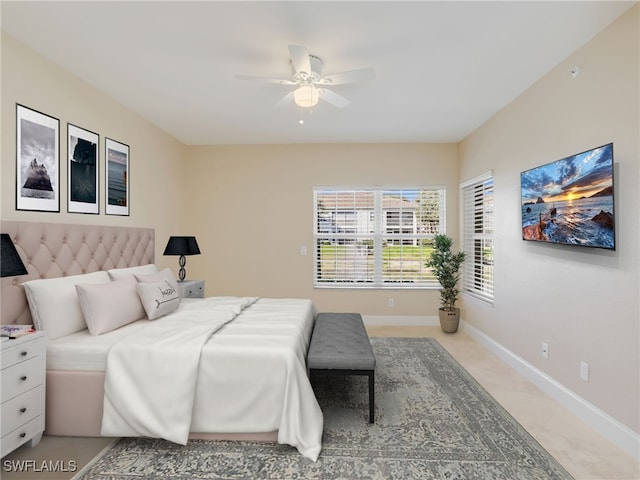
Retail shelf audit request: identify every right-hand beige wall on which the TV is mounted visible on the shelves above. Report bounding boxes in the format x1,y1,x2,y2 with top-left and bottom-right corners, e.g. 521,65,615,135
460,6,640,432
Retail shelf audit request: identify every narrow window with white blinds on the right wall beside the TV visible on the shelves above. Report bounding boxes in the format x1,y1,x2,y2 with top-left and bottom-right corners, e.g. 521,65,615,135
460,172,493,304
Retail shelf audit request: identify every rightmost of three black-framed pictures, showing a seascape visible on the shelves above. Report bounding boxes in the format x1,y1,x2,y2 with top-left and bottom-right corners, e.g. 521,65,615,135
105,138,130,215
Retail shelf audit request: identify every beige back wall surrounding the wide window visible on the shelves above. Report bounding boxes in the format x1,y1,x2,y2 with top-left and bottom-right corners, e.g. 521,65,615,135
186,144,458,316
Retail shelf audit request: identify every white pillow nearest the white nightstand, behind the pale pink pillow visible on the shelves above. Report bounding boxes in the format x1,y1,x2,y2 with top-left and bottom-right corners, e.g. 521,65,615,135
23,271,110,340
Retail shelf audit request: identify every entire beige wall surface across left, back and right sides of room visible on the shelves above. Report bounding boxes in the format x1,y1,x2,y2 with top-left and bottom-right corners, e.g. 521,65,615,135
0,2,640,442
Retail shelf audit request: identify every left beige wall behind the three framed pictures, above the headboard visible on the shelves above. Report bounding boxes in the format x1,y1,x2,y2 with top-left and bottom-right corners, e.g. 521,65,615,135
0,32,186,266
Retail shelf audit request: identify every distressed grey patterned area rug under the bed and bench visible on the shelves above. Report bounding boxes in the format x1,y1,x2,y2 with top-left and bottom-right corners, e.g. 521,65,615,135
74,337,572,480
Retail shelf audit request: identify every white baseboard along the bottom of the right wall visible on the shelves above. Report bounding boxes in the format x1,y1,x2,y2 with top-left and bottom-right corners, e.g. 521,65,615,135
460,322,640,461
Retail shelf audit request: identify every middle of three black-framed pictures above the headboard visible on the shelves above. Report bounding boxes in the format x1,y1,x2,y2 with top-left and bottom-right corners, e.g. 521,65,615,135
67,123,100,214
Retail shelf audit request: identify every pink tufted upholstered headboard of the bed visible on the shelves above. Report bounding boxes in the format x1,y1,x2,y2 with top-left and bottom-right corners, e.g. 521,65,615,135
0,221,155,325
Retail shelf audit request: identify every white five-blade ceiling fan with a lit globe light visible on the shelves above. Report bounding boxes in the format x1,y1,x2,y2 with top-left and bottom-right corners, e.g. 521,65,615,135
236,45,376,108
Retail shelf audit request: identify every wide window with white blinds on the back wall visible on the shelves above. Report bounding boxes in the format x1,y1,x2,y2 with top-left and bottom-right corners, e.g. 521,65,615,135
313,187,445,288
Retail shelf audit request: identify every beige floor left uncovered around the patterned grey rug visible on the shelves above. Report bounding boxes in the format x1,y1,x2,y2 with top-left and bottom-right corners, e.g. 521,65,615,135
0,326,640,480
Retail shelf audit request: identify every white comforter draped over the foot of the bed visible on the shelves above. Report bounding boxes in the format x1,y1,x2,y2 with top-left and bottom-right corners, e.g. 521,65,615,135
102,297,323,461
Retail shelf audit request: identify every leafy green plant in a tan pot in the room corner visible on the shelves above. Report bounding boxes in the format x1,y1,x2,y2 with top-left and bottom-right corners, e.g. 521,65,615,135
427,235,465,333
